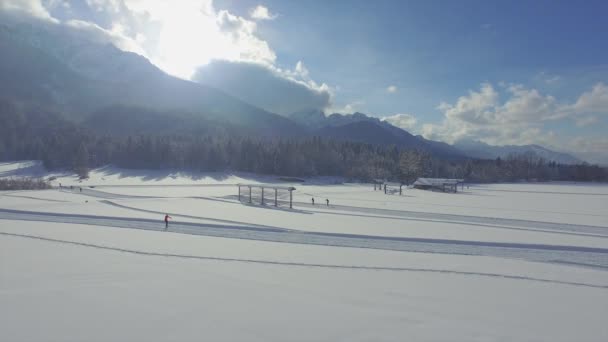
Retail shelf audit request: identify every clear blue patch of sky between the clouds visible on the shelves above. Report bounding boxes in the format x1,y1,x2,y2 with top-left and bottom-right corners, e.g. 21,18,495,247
217,0,608,119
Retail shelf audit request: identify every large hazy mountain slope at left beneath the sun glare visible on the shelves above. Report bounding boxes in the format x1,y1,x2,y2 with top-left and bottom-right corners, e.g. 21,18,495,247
0,25,303,136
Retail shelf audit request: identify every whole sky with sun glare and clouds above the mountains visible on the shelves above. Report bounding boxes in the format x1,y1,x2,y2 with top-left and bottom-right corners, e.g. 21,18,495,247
0,0,608,162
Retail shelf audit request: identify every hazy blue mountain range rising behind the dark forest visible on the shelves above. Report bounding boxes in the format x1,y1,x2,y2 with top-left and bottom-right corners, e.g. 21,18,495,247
0,24,580,163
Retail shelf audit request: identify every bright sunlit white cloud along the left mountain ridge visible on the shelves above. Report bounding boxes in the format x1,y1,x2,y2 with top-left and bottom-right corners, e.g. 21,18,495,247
0,0,333,106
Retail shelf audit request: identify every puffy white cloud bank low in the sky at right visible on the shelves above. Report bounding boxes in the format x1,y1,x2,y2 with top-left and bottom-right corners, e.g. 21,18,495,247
422,83,608,145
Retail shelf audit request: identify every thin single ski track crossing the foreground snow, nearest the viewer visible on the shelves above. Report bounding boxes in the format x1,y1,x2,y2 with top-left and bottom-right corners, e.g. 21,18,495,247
0,232,608,289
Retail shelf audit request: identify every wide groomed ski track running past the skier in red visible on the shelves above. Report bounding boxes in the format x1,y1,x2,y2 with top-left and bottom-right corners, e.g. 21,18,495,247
0,209,608,270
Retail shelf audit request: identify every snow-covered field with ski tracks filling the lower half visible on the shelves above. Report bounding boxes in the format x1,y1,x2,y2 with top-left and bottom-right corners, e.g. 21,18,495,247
0,162,608,341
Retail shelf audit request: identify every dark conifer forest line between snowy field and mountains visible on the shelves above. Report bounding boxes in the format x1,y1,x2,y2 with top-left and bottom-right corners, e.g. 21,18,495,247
0,101,608,184
